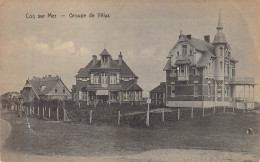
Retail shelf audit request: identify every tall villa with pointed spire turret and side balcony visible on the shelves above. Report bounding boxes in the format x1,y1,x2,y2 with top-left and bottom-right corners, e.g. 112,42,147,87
164,12,255,107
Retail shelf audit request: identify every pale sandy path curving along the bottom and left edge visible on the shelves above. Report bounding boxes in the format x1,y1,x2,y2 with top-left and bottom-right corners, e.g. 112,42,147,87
0,113,260,162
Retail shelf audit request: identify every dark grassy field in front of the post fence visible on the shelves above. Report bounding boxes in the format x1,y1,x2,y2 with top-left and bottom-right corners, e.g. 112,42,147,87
1,109,260,156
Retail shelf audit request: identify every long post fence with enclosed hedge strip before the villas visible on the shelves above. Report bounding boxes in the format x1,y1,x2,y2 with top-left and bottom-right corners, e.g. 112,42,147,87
11,102,238,126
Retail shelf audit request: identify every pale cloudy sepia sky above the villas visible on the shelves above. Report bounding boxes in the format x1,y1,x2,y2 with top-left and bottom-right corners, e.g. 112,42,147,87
0,0,260,101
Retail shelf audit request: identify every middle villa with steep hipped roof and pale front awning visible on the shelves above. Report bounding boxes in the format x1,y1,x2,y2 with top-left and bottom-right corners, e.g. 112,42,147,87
72,49,143,105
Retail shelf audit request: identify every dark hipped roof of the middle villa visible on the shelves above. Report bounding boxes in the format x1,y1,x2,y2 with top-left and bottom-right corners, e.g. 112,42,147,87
75,49,137,77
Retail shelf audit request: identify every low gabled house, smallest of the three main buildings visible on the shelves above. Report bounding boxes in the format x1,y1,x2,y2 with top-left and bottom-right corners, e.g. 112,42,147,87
21,75,71,102
